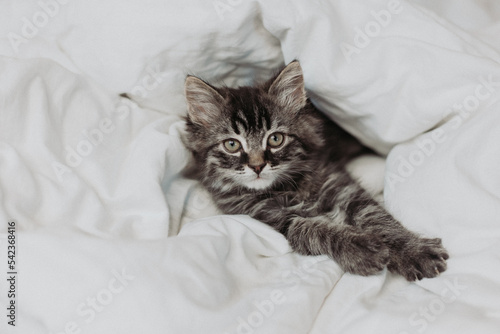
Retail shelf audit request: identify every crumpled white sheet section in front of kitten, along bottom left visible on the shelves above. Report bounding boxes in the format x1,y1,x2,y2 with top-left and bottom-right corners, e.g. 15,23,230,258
2,216,342,334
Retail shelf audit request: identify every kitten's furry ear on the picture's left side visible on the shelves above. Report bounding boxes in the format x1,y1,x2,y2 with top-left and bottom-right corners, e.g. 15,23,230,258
184,76,224,127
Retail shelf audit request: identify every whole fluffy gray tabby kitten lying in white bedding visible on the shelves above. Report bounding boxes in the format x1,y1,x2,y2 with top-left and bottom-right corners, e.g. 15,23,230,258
185,61,448,281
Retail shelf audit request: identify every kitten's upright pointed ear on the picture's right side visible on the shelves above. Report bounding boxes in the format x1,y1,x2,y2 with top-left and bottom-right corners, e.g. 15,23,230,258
268,60,307,112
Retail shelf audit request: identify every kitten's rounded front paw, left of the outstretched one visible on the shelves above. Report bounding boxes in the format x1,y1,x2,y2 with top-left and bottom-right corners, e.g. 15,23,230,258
338,235,390,276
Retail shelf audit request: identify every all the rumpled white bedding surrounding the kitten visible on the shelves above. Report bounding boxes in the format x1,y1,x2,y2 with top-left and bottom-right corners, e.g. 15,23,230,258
0,0,500,334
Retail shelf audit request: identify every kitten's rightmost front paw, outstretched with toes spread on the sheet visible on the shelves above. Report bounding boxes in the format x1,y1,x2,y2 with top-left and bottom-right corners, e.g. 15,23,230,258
387,237,449,281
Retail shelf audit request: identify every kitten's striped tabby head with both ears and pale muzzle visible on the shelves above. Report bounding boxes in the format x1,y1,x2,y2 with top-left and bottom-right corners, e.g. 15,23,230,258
185,61,324,191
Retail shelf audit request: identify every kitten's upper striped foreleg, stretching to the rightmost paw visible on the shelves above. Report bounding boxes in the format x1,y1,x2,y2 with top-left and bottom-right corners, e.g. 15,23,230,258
322,173,448,281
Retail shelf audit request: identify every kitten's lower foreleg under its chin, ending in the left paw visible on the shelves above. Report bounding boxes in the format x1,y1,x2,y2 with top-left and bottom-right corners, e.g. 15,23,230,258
237,193,389,276
